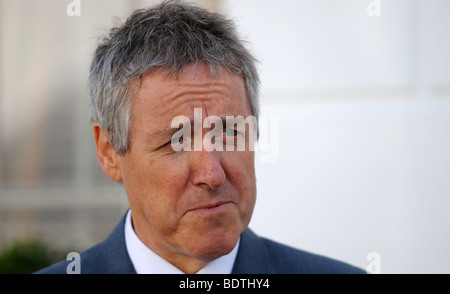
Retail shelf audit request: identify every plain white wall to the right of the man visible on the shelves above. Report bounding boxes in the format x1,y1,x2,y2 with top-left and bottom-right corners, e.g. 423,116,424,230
222,0,450,273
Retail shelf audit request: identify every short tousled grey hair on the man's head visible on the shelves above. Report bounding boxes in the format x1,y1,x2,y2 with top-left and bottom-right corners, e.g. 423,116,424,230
89,1,259,155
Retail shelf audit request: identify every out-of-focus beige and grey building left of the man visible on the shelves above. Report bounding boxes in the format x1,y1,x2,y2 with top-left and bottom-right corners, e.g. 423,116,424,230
0,0,218,250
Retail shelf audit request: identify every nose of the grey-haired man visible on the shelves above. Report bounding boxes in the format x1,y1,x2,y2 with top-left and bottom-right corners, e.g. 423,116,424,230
190,150,225,191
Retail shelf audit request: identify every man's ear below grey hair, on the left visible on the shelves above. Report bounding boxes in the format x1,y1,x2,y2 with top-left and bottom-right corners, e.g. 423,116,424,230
93,123,122,182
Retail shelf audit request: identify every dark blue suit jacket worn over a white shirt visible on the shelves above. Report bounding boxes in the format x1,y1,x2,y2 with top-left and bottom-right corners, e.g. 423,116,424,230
37,212,365,274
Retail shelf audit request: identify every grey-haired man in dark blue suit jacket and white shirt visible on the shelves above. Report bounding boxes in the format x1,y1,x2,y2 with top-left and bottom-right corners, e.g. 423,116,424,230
39,1,363,274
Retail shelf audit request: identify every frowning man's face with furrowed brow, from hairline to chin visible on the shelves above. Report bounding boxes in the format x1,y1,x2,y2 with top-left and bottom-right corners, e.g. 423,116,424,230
114,65,256,267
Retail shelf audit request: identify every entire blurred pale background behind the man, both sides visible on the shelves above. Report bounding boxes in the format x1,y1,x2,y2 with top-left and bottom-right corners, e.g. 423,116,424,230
0,0,450,273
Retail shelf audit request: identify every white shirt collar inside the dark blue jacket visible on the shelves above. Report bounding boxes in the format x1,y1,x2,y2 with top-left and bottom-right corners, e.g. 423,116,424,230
125,209,240,274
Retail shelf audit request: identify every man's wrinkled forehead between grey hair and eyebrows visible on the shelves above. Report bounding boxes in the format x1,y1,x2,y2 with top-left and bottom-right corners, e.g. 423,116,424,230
133,64,251,121
